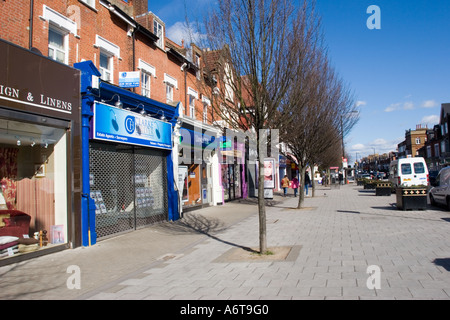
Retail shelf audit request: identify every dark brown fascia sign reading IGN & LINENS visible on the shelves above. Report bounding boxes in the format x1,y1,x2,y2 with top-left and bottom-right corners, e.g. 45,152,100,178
0,41,80,120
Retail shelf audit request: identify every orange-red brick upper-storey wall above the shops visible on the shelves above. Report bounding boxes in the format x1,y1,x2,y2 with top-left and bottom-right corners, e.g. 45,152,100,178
0,0,218,121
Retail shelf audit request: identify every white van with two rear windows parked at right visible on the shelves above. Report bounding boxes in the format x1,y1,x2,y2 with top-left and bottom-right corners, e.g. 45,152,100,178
389,157,430,187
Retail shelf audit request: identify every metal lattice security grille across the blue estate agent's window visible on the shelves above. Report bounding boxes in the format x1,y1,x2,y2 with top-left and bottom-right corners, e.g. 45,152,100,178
89,142,168,238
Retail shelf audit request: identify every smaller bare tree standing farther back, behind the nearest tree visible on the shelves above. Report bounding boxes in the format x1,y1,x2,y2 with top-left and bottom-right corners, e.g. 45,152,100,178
282,43,358,208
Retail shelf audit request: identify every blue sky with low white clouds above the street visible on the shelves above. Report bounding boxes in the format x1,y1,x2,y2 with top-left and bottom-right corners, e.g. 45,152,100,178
149,0,450,163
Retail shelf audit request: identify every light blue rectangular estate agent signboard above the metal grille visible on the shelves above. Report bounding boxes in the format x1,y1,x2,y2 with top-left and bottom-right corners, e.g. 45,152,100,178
93,102,172,150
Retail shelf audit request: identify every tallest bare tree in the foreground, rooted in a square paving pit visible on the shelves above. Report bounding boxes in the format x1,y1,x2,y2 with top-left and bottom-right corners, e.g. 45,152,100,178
199,0,322,253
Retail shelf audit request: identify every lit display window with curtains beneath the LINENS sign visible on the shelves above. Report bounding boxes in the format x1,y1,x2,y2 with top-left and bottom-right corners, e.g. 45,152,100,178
0,119,68,258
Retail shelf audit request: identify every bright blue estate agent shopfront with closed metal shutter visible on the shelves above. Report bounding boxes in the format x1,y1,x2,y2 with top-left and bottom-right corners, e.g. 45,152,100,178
74,61,180,246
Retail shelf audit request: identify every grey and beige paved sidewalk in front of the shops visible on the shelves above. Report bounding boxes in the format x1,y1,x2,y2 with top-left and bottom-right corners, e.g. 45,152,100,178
0,184,450,300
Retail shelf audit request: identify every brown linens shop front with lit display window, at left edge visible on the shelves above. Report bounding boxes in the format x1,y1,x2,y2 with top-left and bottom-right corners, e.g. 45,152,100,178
0,40,81,265
